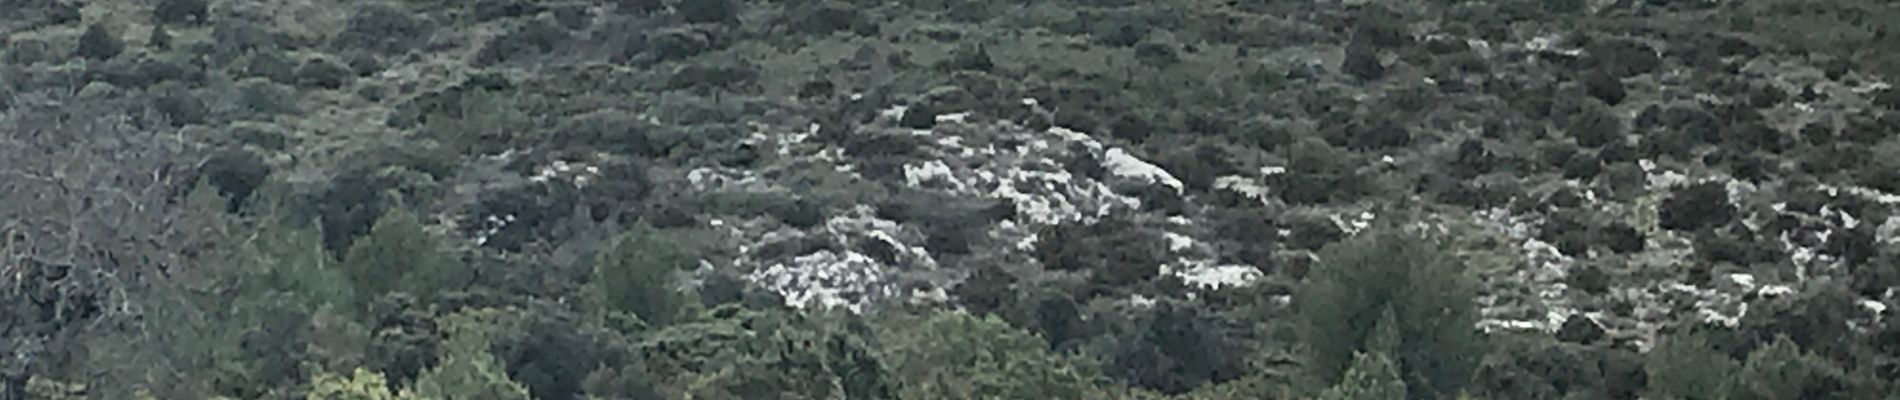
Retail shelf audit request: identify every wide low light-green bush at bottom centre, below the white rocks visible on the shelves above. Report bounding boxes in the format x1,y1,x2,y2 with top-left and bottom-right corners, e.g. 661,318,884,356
882,311,1098,400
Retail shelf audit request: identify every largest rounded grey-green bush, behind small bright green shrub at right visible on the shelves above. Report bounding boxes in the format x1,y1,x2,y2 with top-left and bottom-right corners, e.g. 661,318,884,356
1294,227,1484,398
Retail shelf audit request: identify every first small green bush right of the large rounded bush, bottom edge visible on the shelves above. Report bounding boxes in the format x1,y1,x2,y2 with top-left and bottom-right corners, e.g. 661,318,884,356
1644,332,1740,400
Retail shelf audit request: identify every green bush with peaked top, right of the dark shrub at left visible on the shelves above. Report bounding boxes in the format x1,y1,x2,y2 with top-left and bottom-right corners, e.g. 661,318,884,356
344,207,473,307
